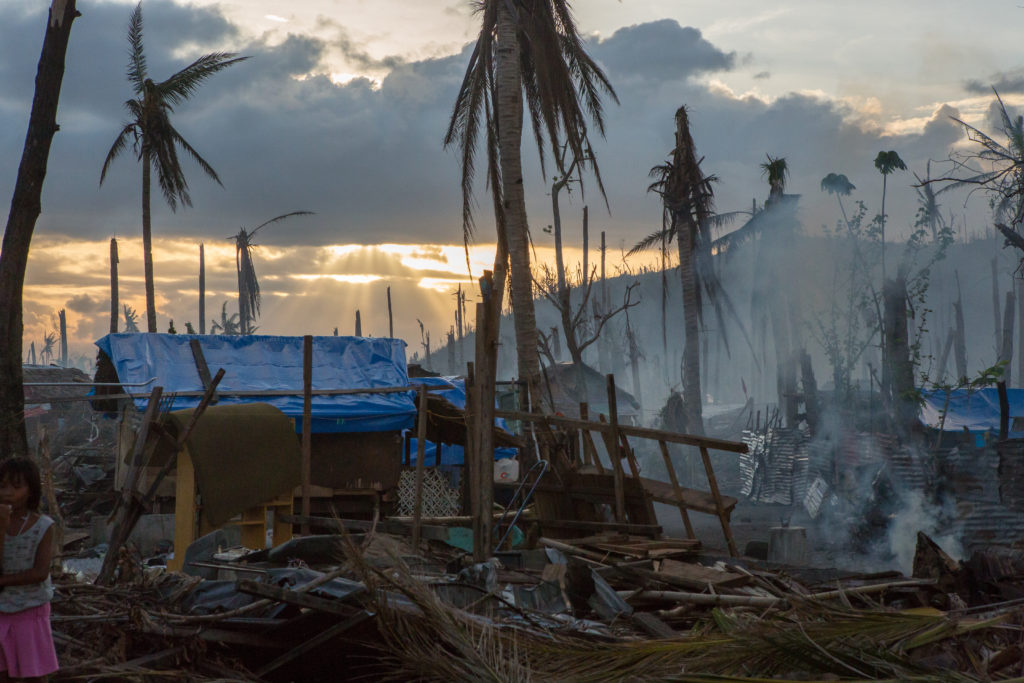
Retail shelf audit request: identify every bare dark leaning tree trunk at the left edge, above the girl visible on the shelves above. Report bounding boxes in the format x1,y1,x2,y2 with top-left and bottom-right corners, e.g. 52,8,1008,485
0,0,78,456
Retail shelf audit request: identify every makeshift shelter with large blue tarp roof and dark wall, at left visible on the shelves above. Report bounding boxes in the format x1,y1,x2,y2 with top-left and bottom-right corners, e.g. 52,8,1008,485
96,334,416,497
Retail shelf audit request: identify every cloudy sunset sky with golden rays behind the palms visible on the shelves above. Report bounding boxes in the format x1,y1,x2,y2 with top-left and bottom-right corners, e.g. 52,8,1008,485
0,0,1024,366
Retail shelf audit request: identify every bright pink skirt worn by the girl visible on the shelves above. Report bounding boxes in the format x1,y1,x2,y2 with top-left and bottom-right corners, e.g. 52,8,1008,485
0,602,59,678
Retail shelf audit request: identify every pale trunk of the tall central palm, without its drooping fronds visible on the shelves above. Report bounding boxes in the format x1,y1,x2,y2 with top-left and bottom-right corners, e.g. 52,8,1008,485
496,2,542,407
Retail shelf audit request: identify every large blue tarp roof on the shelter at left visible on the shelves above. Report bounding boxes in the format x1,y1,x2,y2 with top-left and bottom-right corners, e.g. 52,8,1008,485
96,334,416,433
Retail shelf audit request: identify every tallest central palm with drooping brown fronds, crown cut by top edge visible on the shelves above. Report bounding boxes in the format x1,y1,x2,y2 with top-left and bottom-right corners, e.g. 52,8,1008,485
444,0,617,405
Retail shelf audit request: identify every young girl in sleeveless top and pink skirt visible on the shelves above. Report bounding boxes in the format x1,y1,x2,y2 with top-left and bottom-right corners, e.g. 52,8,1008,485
0,458,57,683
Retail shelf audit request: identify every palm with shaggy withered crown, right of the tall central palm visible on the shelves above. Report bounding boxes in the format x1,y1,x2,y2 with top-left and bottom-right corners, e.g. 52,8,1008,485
648,106,715,434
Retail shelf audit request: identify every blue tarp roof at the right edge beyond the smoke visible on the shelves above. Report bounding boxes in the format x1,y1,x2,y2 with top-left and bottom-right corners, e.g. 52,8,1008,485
921,388,1024,438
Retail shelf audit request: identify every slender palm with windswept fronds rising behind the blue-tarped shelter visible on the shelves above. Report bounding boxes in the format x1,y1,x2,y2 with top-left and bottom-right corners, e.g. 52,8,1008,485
99,2,248,332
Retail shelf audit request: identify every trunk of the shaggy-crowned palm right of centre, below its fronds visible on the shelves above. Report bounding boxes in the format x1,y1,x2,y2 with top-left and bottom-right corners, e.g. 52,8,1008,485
673,217,703,434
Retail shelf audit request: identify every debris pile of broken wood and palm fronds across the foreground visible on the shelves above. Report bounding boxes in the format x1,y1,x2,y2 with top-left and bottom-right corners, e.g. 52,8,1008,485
53,520,1024,681
